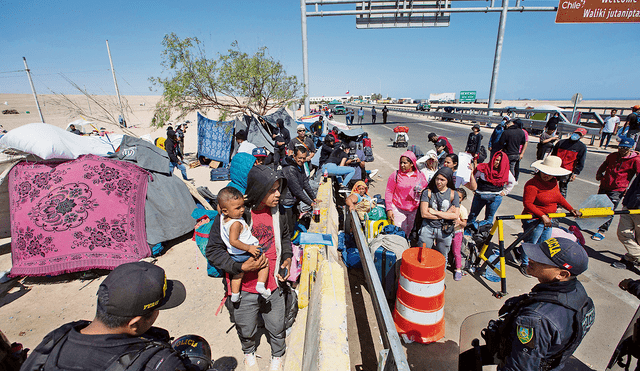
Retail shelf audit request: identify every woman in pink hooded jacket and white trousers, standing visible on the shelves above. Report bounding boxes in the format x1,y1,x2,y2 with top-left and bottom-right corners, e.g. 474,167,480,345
384,151,428,237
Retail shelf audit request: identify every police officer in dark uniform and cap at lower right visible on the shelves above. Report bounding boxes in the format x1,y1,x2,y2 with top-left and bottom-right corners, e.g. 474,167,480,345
460,238,595,371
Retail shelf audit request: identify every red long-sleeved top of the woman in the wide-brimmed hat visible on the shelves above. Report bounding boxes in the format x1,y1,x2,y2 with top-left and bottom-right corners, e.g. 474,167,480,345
522,175,573,217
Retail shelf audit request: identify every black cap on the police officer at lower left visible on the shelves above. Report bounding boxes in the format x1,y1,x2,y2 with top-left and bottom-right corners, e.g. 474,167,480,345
98,262,187,317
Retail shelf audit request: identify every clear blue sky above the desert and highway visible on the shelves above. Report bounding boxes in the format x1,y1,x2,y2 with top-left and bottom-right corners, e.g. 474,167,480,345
0,0,640,100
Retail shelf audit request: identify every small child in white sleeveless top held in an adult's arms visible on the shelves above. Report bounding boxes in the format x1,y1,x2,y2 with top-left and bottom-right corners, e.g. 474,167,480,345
218,187,271,303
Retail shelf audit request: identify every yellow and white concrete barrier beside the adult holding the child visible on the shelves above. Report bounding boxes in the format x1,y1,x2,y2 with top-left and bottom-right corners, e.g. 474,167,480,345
284,180,350,371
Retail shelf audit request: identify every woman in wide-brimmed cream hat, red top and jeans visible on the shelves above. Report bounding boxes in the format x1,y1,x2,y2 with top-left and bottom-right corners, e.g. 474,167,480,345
517,156,582,277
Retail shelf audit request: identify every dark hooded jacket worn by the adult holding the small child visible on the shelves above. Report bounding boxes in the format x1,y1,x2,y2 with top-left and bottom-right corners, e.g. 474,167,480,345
205,165,293,282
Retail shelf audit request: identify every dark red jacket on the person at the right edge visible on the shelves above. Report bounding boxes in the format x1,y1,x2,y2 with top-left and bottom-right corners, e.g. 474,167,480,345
596,151,640,191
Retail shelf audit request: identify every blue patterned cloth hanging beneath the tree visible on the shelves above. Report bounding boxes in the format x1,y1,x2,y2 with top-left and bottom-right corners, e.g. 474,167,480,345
198,112,233,164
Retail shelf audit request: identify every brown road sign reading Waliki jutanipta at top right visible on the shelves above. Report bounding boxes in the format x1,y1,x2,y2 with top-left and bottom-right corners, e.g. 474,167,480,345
556,0,640,23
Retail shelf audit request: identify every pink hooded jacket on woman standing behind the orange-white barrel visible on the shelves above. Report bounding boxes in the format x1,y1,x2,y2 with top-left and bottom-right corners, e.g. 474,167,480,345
384,151,427,211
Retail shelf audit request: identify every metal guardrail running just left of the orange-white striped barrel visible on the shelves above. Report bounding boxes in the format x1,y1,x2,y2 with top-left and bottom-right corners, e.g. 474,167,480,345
348,210,409,371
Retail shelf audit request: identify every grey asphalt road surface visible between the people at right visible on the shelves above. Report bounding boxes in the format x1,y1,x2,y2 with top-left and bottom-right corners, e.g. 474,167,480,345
335,107,640,370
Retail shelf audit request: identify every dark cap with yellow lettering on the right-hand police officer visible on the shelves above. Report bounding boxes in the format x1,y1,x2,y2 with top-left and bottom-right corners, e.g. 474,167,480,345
522,237,589,276
